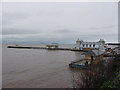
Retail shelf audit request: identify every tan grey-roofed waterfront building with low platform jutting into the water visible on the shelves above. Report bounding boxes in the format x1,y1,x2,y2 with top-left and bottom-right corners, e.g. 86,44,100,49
69,50,104,68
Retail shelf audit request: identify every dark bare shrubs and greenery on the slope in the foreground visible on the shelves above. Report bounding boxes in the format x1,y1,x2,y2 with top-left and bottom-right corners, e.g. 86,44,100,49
72,56,120,88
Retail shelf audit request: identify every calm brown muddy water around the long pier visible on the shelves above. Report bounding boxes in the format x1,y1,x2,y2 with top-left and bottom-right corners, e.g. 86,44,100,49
2,45,81,88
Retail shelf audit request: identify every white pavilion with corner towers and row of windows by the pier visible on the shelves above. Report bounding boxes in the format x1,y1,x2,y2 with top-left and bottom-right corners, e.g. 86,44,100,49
75,39,106,50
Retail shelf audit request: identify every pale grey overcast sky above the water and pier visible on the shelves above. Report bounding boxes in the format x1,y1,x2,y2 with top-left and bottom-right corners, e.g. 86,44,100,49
2,2,118,43
